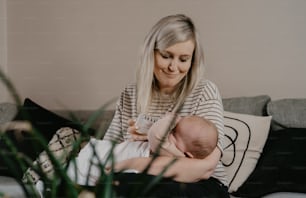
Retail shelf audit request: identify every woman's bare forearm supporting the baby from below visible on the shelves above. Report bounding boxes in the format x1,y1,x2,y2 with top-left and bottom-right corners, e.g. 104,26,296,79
115,145,221,182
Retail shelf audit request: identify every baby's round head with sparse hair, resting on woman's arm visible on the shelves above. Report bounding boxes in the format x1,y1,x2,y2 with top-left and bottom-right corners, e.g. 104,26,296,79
173,115,218,159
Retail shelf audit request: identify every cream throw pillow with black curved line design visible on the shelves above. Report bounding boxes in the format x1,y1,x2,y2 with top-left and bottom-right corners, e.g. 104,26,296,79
222,111,271,192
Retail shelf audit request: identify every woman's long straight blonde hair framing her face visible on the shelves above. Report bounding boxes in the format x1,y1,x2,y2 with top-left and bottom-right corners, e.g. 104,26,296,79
136,14,204,113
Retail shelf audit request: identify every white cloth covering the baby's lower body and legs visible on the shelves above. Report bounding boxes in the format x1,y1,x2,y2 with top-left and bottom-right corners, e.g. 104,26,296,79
67,138,150,186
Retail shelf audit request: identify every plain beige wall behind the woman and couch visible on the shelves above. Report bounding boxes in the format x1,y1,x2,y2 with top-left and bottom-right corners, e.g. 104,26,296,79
4,0,306,109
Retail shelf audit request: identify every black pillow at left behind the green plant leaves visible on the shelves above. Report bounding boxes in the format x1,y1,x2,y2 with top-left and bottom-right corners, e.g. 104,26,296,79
0,98,94,177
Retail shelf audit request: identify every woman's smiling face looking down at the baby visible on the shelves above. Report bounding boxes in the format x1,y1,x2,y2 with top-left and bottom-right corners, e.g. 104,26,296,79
154,40,195,93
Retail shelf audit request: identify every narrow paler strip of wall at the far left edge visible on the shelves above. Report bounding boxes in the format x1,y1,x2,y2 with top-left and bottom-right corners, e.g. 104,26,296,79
0,0,8,103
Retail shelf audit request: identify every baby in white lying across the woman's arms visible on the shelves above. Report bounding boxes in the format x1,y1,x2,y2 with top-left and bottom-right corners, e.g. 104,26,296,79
68,113,218,185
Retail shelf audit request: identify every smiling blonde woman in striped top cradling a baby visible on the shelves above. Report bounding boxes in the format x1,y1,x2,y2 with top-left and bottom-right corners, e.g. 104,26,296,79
104,15,229,197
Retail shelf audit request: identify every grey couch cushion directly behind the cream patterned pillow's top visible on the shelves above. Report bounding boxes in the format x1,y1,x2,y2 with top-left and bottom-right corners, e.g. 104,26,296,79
222,95,271,116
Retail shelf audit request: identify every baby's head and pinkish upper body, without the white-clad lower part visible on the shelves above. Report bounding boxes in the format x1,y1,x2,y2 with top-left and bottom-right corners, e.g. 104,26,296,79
148,113,218,159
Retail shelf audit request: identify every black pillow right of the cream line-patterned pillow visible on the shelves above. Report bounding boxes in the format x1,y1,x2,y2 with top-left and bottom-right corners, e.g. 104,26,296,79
232,128,306,198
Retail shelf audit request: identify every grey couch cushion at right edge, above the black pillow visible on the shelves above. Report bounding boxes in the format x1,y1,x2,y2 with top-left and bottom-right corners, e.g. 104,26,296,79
267,99,306,130
